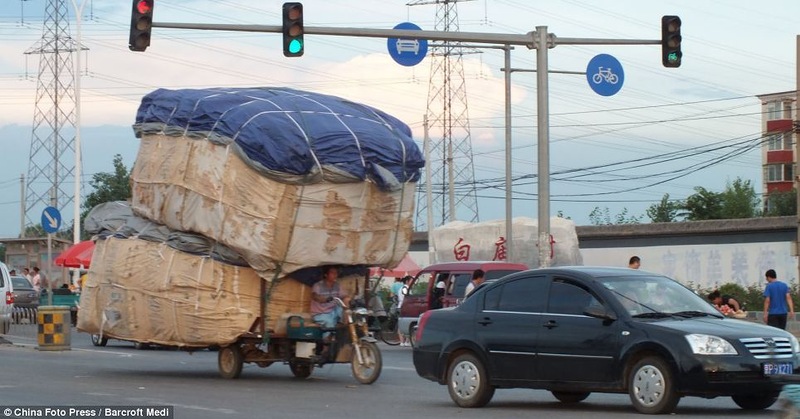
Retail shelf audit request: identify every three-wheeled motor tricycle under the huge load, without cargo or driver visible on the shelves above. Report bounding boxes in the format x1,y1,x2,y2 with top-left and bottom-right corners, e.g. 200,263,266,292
218,298,383,384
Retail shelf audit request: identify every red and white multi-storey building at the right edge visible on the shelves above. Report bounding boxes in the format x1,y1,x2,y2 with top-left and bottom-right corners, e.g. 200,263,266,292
758,90,797,211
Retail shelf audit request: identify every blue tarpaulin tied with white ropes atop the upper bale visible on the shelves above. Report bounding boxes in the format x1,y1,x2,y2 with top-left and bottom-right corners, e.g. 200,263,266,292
134,87,425,190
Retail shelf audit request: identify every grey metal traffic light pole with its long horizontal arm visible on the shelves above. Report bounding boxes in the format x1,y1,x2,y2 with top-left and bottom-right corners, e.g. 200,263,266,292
153,22,662,267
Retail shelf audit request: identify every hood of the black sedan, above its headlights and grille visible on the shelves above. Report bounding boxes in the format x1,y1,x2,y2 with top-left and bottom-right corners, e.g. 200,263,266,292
651,317,790,339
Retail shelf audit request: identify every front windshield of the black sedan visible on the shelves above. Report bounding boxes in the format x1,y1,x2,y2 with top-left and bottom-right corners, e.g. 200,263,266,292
600,276,722,318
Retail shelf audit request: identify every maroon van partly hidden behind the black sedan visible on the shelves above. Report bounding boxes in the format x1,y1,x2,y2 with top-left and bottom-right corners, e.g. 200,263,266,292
397,261,528,342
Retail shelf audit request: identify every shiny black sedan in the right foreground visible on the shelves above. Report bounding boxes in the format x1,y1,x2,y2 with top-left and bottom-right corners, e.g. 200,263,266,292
414,267,800,414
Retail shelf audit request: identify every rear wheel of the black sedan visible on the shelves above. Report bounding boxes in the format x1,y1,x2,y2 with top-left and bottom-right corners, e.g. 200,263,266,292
447,353,494,407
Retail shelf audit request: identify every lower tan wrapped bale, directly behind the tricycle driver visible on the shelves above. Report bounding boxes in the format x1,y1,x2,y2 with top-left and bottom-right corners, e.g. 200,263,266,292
78,237,355,347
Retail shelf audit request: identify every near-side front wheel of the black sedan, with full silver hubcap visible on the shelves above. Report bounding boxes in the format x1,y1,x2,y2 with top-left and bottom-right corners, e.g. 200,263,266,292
628,356,679,415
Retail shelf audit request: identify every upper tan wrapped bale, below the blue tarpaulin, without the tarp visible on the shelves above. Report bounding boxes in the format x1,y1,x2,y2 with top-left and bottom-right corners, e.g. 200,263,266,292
131,134,415,278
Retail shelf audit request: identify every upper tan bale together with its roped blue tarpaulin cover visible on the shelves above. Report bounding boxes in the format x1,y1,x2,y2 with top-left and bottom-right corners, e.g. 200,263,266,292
132,88,424,278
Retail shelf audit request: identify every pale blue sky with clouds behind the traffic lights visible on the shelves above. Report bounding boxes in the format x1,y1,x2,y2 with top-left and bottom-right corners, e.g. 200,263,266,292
0,0,800,237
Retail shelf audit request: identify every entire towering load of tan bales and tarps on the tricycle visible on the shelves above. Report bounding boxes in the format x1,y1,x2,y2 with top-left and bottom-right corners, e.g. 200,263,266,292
78,88,424,347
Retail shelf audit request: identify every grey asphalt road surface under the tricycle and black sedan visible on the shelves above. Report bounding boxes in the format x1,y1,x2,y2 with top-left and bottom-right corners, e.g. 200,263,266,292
0,329,776,419
